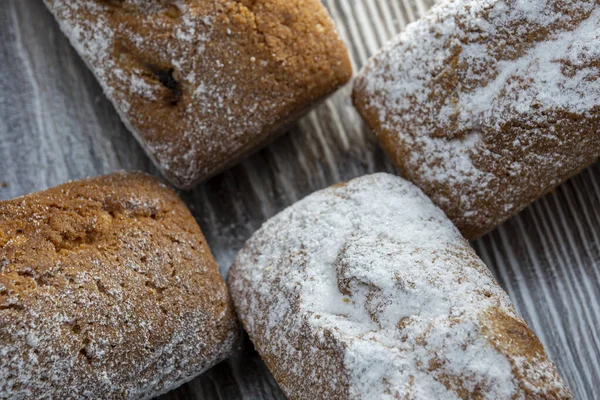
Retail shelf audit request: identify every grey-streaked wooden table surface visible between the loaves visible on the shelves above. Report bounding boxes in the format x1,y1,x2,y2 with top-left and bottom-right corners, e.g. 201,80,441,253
0,0,600,400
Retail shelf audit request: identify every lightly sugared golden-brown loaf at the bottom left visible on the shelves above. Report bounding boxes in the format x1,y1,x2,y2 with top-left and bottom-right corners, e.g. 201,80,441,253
0,173,239,399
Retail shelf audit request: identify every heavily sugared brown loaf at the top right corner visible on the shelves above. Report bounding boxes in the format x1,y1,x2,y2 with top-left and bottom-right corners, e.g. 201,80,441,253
354,0,600,239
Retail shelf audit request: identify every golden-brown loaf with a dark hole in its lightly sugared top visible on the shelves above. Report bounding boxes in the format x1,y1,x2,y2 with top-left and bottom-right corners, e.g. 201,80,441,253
44,0,352,188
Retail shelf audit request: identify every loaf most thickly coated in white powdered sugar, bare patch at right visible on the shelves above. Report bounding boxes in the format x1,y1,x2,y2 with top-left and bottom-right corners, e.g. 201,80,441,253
228,174,571,400
